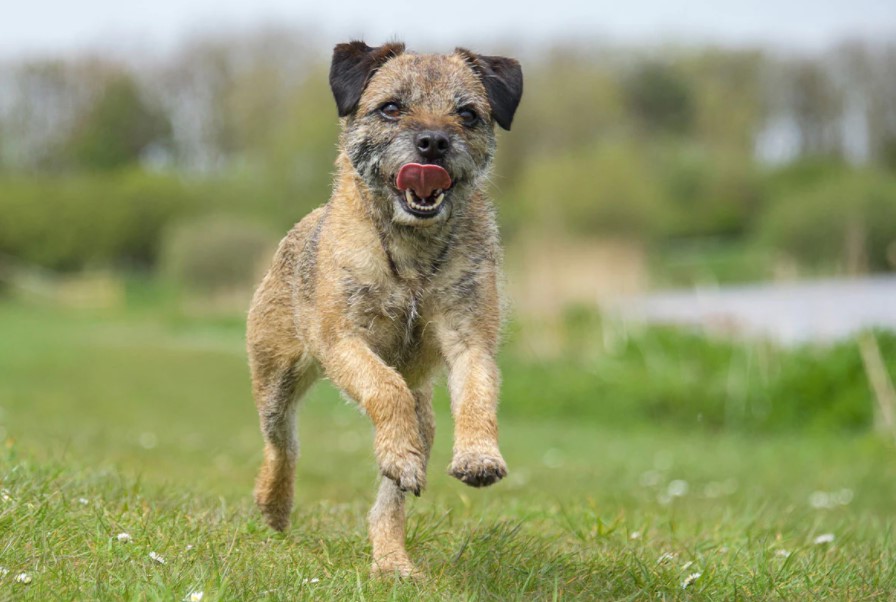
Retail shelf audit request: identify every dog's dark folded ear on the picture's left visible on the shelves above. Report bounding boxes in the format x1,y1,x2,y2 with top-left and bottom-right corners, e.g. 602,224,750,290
330,41,404,117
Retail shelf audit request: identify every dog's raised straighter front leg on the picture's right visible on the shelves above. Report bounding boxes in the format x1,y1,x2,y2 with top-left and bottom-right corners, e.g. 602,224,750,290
445,337,507,487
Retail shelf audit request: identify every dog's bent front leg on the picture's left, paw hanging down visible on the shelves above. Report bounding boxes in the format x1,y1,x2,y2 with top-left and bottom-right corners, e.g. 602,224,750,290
321,336,426,495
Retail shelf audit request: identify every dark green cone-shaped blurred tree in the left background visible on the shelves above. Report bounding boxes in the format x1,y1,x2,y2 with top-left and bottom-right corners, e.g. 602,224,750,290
64,72,171,171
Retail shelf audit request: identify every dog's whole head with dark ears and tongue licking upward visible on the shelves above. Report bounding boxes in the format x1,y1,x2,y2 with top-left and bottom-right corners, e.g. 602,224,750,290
330,42,523,226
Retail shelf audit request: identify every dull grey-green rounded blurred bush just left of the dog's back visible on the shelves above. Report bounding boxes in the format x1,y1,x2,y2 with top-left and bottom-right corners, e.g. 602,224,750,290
159,215,277,294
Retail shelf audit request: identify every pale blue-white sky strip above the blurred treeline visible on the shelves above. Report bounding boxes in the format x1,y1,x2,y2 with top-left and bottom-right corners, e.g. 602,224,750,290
0,0,896,57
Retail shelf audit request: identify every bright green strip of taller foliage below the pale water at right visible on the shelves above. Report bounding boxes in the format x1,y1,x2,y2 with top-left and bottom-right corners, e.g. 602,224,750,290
502,308,896,432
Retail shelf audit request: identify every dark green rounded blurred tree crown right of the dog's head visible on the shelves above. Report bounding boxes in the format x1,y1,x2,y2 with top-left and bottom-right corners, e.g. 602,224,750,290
623,61,695,134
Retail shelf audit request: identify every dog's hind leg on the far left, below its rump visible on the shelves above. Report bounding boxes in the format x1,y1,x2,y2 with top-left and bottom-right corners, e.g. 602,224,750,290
252,346,317,531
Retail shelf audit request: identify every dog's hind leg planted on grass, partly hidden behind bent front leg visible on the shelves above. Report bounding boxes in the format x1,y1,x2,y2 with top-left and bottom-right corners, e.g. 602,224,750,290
368,387,435,577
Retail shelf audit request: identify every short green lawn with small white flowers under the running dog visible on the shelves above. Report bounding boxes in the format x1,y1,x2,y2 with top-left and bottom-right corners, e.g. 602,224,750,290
0,302,896,600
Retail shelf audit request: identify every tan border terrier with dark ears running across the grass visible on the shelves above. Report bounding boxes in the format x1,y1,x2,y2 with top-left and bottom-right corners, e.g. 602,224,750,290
247,42,523,576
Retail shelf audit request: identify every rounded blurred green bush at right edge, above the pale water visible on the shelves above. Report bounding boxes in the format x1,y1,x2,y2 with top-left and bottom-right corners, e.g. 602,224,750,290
759,167,896,270
